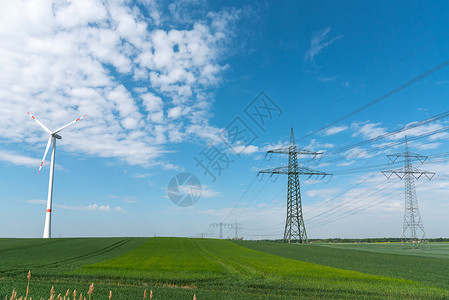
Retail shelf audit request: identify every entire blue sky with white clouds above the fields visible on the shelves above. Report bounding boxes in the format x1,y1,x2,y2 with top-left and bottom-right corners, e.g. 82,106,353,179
0,0,449,239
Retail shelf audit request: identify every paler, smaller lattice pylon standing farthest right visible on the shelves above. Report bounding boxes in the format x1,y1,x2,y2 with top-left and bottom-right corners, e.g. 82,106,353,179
382,136,435,248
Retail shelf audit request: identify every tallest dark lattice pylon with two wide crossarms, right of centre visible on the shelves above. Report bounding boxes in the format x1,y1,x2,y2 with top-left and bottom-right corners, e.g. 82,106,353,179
259,128,331,243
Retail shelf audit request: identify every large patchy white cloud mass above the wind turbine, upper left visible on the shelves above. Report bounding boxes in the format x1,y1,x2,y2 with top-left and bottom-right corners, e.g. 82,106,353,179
0,0,239,166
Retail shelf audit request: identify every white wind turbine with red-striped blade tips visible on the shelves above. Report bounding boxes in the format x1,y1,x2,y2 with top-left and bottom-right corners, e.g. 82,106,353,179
28,113,86,239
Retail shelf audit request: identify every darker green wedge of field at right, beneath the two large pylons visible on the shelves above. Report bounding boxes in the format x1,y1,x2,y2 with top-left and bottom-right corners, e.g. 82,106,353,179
237,241,449,289
